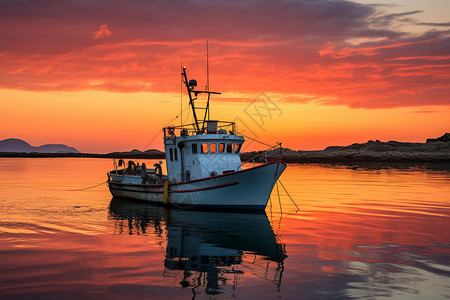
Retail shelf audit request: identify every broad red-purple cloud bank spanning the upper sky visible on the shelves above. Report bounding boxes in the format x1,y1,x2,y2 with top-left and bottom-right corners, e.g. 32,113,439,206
0,0,450,108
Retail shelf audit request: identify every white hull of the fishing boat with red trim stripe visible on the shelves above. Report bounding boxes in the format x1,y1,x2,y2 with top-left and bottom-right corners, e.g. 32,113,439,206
108,162,286,210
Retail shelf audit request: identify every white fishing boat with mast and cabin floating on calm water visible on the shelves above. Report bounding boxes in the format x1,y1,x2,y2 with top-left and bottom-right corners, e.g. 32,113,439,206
108,67,286,210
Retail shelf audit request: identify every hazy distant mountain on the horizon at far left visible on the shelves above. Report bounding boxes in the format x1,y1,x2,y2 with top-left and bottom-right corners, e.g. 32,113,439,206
0,139,80,153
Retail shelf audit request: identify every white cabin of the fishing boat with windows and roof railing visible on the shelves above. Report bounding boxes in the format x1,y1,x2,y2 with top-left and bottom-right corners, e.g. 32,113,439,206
164,121,245,182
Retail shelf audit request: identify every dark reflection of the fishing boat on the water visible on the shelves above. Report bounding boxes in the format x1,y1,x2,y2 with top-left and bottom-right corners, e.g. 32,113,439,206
109,198,287,295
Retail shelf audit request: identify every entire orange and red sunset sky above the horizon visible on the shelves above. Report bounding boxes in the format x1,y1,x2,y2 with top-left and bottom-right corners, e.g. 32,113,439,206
0,0,450,152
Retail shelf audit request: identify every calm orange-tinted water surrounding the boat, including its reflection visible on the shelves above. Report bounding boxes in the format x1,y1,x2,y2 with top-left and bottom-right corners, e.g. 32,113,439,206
0,158,450,300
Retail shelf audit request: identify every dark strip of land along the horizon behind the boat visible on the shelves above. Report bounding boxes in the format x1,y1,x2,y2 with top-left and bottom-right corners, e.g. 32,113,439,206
0,133,450,163
